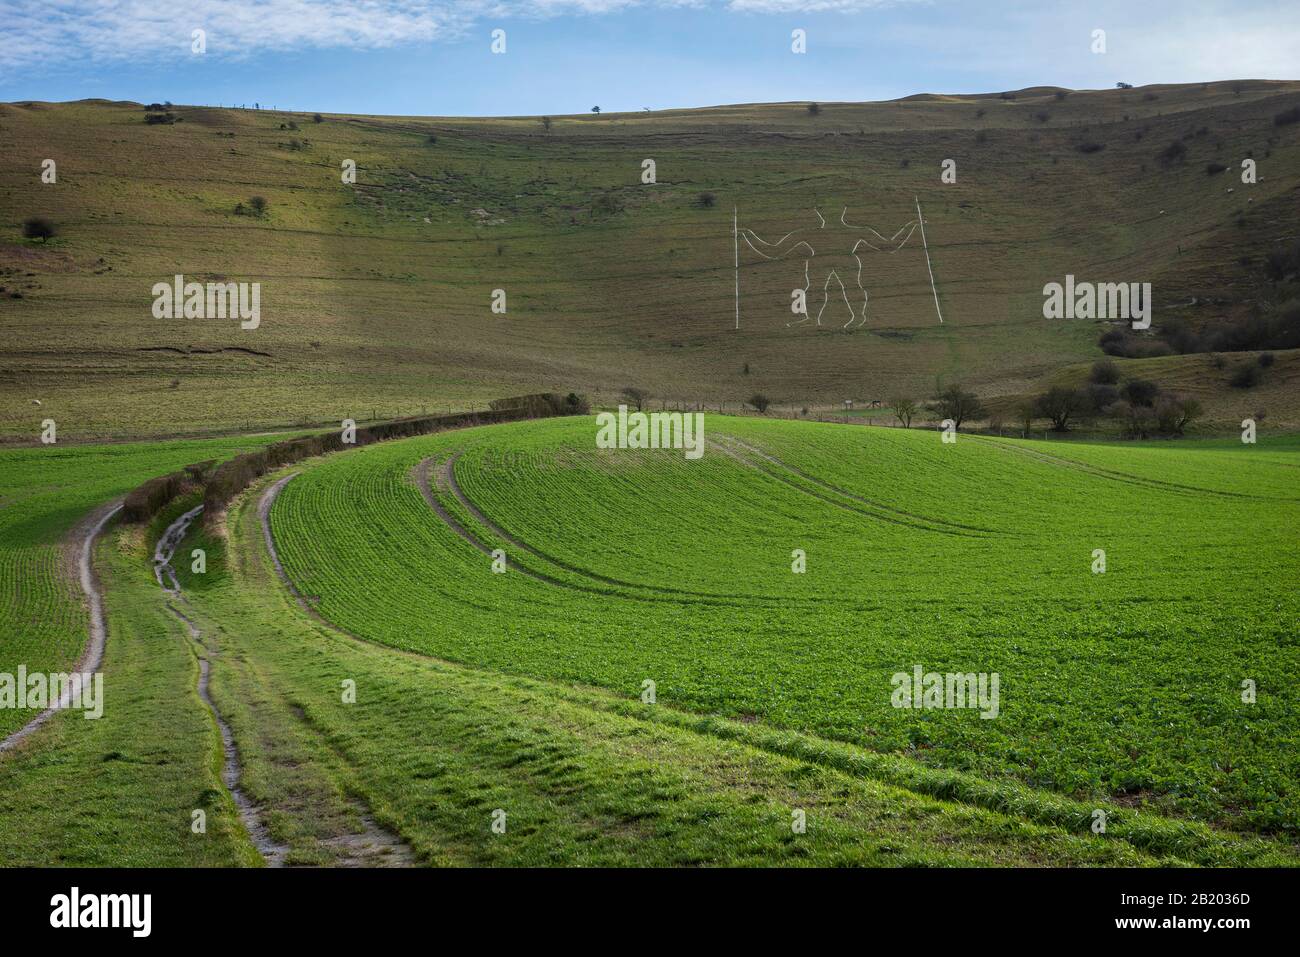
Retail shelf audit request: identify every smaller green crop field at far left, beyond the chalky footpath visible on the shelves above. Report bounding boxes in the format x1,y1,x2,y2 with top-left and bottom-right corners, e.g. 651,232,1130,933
0,436,289,735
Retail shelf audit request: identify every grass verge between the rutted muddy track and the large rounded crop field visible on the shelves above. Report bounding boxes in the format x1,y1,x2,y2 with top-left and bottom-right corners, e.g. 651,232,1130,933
196,475,1296,866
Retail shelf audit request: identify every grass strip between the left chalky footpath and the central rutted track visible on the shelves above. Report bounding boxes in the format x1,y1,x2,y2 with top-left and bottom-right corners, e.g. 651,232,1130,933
0,522,260,867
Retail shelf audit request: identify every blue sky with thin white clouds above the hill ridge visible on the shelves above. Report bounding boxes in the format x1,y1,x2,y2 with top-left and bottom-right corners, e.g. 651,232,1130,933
0,0,1300,116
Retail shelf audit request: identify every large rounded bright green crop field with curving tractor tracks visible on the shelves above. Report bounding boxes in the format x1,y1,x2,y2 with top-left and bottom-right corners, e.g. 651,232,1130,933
273,416,1300,833
